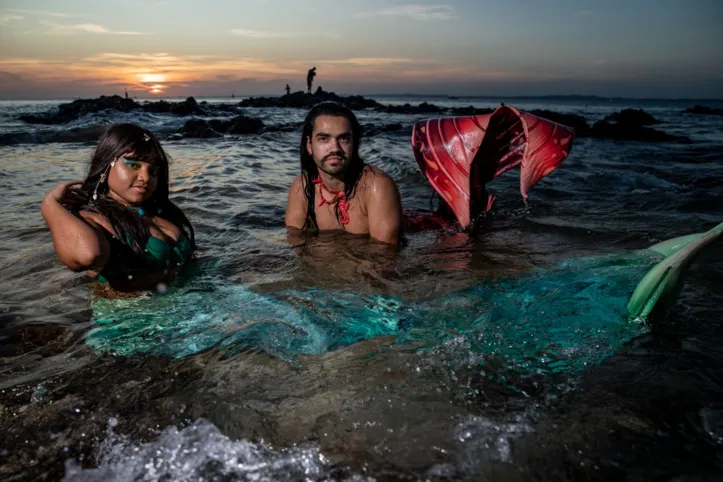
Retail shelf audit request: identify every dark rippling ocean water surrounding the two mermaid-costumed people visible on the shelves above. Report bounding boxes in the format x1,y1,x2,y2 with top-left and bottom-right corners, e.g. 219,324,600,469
0,97,723,480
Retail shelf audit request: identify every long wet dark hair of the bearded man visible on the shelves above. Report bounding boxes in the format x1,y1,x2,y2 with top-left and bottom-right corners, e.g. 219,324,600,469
299,101,365,228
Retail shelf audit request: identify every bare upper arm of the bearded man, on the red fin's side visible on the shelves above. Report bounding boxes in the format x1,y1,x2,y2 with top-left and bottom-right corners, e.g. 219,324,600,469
367,173,402,245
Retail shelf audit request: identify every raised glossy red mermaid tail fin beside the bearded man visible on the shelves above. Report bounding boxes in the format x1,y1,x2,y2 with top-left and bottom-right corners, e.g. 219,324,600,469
412,105,575,228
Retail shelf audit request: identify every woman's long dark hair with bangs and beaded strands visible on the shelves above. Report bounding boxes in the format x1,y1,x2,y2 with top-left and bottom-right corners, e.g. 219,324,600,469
60,124,196,257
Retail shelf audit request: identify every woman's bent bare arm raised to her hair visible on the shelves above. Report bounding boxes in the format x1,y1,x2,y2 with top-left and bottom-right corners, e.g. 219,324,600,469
40,181,110,271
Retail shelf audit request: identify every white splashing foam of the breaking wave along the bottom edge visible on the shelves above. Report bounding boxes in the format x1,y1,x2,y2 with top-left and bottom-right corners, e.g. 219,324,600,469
63,419,374,482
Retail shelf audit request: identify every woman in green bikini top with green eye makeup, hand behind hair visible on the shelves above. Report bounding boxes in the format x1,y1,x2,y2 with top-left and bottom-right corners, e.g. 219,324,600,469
41,124,196,291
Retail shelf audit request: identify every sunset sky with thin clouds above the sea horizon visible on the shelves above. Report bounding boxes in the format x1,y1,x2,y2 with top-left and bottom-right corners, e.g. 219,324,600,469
0,0,723,99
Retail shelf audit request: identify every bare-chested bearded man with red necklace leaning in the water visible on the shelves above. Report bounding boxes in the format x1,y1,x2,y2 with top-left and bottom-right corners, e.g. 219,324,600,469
286,102,402,245
